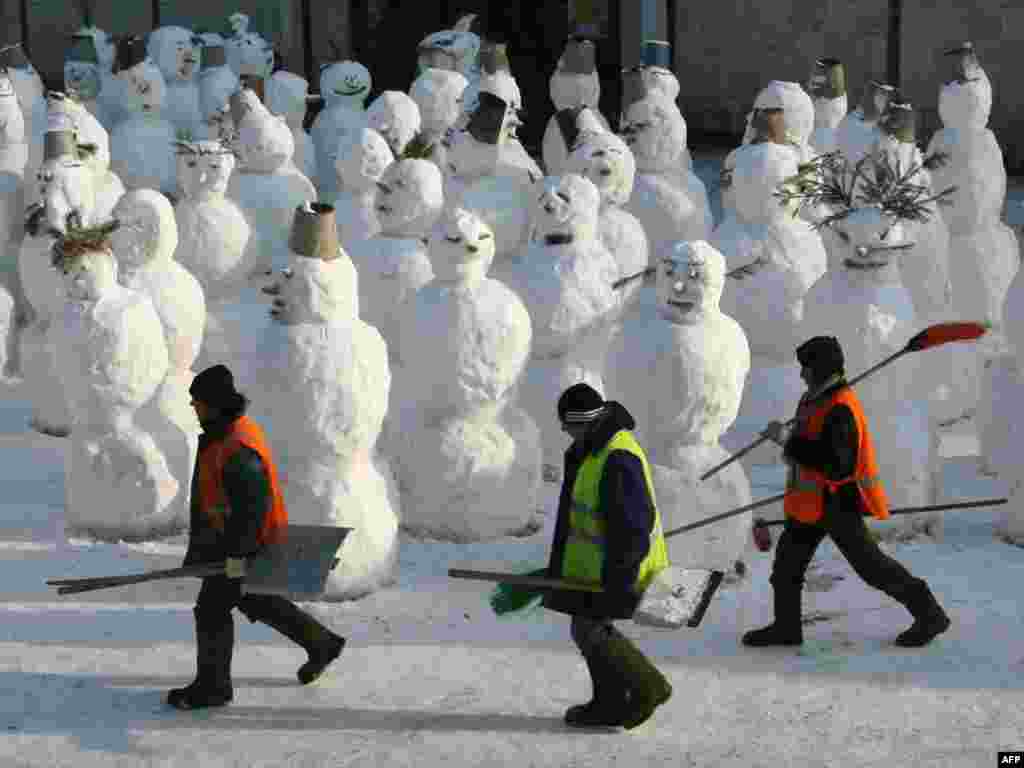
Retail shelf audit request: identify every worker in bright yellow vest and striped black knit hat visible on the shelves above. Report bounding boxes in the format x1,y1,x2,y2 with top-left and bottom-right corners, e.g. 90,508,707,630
544,383,672,729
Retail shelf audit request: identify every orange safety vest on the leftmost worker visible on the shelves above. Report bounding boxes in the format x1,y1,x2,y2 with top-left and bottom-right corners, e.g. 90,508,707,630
199,416,288,545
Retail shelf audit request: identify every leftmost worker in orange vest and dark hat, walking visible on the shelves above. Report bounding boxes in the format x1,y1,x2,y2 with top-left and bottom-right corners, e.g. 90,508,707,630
167,366,345,710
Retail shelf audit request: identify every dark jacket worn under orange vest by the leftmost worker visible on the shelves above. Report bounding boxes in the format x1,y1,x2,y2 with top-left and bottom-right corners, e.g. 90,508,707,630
183,407,270,565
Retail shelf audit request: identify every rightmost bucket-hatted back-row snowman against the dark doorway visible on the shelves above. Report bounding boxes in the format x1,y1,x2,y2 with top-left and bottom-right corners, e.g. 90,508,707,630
542,36,608,176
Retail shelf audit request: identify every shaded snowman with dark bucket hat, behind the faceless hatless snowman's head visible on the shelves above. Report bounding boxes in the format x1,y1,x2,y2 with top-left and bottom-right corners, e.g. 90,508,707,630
111,37,177,197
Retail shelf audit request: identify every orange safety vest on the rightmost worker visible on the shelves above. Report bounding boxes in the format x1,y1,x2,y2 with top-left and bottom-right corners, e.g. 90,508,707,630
782,386,889,523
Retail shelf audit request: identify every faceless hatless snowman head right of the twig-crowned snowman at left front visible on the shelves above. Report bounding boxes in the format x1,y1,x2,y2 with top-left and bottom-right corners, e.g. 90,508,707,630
111,189,178,270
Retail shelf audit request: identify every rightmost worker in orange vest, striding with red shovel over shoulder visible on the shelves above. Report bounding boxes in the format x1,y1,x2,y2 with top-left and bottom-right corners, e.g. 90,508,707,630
742,336,949,647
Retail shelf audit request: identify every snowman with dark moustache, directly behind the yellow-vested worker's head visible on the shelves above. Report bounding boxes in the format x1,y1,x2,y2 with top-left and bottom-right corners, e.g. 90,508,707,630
501,173,621,479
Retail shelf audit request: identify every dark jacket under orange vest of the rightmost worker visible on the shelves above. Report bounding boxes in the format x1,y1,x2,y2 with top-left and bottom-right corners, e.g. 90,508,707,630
783,381,864,515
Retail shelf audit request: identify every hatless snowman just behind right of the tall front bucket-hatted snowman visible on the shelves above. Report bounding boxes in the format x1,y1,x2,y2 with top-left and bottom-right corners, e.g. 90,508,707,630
334,127,394,246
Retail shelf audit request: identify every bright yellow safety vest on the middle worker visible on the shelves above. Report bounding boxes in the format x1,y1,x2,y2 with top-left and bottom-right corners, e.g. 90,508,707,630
562,429,669,592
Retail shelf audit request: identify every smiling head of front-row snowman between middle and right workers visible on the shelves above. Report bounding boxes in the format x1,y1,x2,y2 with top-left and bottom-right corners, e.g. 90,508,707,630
654,240,725,325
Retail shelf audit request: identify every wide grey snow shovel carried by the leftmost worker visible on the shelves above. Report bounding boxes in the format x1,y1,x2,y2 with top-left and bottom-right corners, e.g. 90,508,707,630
46,525,352,600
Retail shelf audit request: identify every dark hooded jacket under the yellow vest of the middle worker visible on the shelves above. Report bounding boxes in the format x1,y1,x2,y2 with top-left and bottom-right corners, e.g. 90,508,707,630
544,400,654,618
